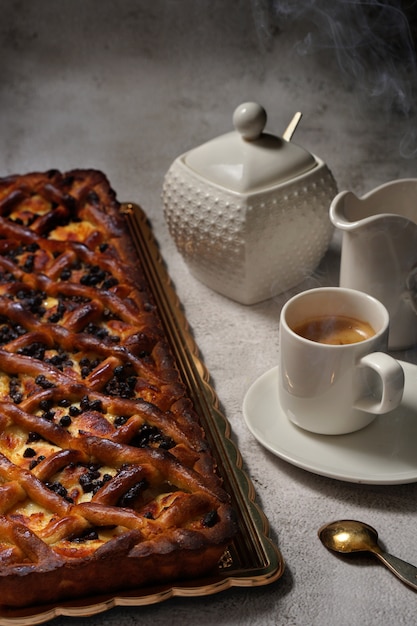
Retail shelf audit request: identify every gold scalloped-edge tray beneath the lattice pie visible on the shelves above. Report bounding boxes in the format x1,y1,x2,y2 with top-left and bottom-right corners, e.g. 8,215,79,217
0,203,284,626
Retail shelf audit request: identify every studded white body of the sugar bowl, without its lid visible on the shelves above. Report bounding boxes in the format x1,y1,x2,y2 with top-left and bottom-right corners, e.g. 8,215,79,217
163,157,337,304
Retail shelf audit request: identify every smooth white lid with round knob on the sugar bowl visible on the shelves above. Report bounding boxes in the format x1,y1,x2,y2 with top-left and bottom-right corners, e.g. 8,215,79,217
184,102,317,193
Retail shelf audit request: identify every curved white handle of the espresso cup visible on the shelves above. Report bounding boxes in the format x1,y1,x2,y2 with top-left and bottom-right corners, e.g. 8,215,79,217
355,352,404,415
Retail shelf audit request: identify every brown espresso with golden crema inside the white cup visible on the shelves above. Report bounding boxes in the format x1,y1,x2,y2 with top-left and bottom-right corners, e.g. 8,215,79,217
293,315,375,346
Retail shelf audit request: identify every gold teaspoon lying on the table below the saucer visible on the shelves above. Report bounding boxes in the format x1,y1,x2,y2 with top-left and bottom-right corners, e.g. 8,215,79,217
318,520,417,590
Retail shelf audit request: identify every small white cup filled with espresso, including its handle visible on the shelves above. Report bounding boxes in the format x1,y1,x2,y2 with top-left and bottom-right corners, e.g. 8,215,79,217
279,287,404,435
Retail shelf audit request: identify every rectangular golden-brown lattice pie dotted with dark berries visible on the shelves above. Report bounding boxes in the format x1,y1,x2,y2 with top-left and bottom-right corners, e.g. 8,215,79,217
0,170,235,607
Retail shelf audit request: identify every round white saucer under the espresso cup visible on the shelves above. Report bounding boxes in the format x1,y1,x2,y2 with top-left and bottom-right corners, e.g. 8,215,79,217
243,362,417,485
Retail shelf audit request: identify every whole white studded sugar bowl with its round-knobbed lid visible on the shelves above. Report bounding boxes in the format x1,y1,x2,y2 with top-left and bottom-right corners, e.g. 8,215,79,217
162,102,337,304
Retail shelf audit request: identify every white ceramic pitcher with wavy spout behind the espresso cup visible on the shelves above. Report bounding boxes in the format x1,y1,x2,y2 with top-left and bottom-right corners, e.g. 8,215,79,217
330,178,417,350
